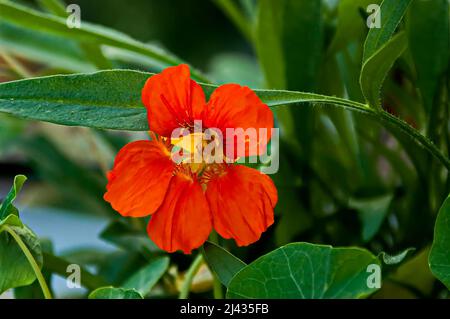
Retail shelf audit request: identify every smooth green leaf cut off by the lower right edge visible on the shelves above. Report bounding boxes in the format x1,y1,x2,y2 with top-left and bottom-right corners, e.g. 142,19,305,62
428,196,450,289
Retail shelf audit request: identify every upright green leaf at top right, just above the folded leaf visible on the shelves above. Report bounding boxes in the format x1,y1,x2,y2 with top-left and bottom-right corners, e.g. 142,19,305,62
363,0,412,64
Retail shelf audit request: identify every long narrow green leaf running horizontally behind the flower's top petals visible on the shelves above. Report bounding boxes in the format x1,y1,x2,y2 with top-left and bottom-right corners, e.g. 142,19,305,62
0,70,368,131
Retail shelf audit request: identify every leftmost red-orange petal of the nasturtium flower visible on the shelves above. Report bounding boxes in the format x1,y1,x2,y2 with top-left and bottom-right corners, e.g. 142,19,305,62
104,140,175,217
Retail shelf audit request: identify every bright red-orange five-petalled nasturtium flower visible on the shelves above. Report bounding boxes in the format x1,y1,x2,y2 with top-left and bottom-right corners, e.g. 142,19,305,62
104,65,277,253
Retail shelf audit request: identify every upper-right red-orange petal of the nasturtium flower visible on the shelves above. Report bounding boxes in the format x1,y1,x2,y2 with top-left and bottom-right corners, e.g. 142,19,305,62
203,84,274,158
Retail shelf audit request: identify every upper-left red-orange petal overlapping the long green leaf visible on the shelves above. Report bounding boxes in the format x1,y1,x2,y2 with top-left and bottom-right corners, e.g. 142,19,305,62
142,64,206,137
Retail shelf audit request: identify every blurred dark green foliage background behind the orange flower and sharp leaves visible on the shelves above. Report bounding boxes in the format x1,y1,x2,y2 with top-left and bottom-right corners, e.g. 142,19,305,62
0,0,450,298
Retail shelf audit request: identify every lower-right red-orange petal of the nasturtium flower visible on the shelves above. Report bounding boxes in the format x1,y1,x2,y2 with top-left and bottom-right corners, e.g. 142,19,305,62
206,165,278,246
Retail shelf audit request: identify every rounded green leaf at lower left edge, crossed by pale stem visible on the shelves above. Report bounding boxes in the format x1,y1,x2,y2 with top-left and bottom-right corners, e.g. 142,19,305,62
0,225,42,294
